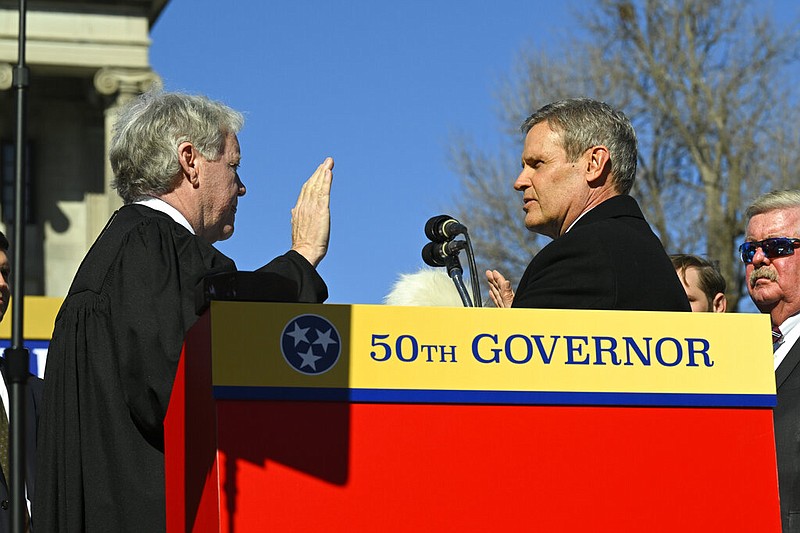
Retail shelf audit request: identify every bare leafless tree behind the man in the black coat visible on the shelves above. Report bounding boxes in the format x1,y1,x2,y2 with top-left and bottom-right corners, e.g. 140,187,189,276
453,0,800,309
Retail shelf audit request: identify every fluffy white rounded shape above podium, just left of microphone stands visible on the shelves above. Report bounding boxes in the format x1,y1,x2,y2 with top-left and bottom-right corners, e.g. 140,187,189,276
383,268,464,307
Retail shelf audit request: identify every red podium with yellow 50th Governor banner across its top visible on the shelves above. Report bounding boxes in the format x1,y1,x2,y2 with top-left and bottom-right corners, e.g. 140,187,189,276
165,301,780,533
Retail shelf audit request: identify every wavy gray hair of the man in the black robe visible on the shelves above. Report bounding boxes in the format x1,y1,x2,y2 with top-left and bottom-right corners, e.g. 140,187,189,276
109,91,244,204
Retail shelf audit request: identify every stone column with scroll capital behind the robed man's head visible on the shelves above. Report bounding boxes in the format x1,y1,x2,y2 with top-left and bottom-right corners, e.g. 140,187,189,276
86,67,161,242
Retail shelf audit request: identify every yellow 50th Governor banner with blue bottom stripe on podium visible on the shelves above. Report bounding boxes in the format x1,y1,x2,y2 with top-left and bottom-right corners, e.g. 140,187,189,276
210,301,775,407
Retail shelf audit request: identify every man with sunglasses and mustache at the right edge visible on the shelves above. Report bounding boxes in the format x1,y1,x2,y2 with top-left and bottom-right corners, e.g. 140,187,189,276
739,190,800,532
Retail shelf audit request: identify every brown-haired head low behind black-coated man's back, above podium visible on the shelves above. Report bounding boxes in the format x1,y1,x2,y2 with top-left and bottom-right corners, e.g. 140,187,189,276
670,254,728,313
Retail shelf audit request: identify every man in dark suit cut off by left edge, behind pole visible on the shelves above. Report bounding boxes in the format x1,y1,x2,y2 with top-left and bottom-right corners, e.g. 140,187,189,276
0,231,42,533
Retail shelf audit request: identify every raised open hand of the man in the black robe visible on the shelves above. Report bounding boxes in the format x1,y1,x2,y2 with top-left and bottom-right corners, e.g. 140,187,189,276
292,157,333,267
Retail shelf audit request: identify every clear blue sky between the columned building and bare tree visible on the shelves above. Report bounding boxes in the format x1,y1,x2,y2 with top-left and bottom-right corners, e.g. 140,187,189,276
150,0,797,303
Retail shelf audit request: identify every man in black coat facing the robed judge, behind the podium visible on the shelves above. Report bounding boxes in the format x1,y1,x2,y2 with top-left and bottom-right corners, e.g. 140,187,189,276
486,99,690,311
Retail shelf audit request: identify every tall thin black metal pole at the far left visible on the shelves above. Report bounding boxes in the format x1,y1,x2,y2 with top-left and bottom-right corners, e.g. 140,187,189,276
6,0,30,533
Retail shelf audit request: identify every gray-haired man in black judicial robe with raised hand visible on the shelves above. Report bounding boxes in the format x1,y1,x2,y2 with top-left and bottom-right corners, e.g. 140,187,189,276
33,93,333,532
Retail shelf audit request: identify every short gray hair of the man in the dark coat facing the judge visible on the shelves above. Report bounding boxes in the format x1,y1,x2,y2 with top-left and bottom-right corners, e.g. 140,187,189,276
521,98,638,194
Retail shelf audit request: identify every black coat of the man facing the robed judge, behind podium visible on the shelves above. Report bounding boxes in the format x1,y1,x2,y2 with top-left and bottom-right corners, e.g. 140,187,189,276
513,196,690,311
